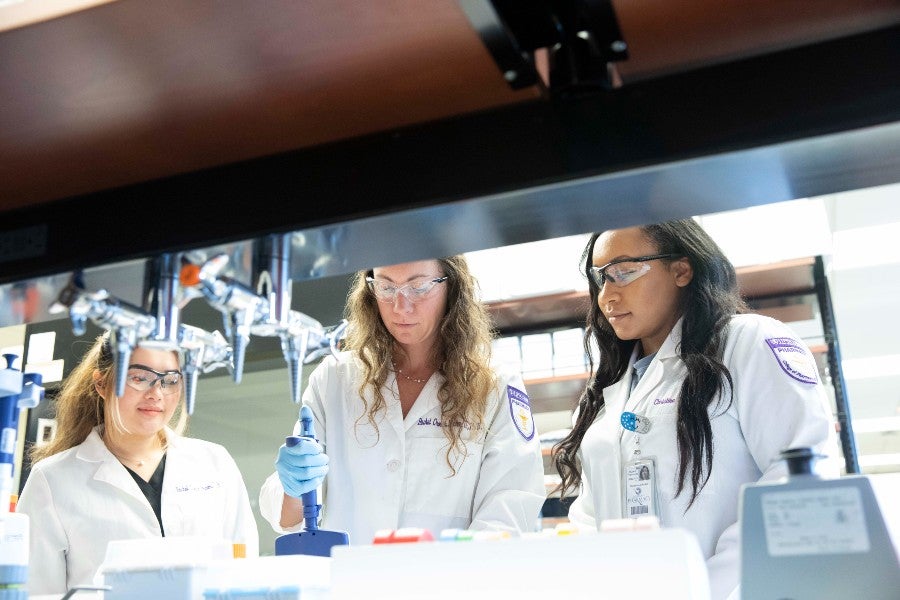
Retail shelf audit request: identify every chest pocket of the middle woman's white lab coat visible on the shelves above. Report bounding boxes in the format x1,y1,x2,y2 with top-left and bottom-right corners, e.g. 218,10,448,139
406,435,484,521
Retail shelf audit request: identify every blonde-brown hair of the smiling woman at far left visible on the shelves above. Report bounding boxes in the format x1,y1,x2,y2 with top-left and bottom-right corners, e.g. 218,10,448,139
29,333,187,463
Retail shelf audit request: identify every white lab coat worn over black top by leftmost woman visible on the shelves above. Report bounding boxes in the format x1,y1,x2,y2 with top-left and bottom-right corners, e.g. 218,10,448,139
16,429,259,595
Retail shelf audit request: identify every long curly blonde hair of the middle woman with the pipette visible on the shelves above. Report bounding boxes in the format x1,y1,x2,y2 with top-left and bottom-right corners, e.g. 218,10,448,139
344,255,495,476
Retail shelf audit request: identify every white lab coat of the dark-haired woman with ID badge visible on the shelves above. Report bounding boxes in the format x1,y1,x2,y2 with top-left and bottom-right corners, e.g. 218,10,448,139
569,314,839,599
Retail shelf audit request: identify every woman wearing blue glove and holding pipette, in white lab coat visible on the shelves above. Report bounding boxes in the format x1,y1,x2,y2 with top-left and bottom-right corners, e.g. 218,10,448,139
260,256,545,544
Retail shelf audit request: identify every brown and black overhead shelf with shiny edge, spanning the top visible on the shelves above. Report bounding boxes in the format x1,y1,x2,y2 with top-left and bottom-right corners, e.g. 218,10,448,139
0,0,900,323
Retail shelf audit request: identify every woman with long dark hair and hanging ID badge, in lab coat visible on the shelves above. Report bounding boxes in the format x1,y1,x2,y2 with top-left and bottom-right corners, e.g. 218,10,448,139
554,219,837,598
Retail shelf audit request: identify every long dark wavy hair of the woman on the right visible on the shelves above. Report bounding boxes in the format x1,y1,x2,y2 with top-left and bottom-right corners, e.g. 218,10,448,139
553,219,748,506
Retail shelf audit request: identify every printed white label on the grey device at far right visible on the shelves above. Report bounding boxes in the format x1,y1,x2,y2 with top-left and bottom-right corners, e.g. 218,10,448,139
761,487,869,556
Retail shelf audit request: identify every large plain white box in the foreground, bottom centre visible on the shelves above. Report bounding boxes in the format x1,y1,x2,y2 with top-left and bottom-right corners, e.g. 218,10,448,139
331,529,710,600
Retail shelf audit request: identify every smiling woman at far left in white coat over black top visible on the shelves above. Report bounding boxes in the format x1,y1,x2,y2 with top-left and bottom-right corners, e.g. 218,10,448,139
17,334,259,595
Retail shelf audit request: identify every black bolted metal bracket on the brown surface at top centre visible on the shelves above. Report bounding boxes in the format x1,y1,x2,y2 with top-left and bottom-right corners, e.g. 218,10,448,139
460,0,628,94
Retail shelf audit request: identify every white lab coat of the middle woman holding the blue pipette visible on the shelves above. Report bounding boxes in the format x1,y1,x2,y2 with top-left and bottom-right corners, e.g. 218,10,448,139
259,352,546,544
